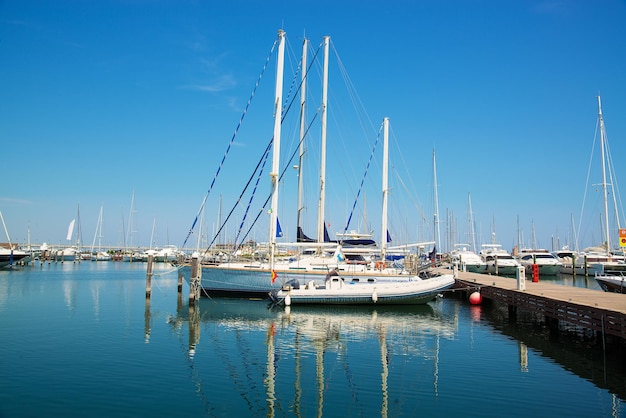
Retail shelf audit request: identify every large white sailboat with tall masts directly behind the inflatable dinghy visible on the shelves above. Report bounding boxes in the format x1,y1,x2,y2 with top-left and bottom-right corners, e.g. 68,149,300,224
184,31,448,297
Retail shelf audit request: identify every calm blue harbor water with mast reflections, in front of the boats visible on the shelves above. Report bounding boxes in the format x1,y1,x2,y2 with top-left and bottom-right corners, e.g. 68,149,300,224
0,262,626,417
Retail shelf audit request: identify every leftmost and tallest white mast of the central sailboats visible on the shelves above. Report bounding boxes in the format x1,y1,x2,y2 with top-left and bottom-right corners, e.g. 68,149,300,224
269,29,285,268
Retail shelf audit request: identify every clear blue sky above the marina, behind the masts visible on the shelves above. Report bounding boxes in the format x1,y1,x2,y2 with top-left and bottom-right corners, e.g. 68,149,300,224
0,0,626,253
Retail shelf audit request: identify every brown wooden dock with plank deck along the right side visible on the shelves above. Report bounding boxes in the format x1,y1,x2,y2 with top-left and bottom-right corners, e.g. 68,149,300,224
447,270,626,340
